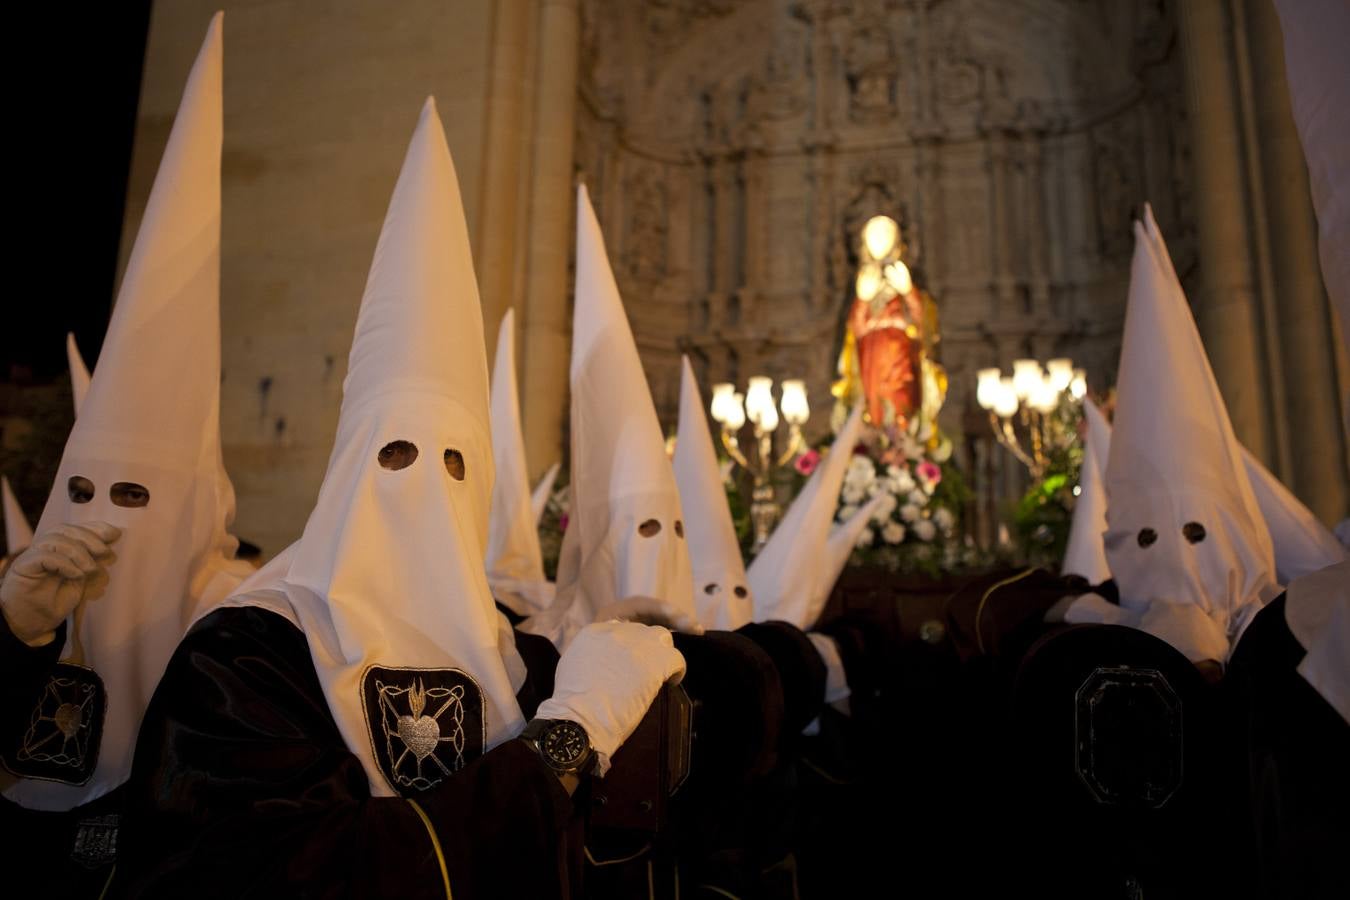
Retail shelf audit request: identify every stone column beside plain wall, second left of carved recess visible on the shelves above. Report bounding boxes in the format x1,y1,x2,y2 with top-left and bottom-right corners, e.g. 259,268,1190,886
477,0,534,358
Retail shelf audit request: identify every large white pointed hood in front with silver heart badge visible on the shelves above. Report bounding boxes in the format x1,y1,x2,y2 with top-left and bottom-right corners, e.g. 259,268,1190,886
214,99,524,796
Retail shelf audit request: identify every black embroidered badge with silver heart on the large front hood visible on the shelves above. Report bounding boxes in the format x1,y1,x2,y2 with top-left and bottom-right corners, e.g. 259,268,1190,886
362,665,487,795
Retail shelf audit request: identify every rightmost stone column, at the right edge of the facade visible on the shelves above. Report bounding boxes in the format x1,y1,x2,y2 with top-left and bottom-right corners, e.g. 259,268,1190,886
1238,0,1350,524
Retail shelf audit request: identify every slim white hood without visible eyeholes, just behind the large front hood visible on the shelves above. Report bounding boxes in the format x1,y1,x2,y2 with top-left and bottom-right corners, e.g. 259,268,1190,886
487,309,554,615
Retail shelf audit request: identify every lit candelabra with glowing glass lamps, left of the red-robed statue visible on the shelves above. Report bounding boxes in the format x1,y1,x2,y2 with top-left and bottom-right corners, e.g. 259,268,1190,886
711,375,811,553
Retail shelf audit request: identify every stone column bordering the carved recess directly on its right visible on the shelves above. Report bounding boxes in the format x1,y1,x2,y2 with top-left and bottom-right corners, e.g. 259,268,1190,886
1177,0,1273,463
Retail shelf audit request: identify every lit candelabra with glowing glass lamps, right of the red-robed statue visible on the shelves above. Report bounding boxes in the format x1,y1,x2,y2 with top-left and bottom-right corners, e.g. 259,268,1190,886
975,359,1087,479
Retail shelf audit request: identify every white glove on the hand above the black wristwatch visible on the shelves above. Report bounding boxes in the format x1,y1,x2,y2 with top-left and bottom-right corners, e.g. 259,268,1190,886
535,622,684,776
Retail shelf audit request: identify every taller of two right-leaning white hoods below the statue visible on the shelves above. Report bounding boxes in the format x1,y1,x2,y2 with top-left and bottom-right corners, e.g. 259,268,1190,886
748,407,867,629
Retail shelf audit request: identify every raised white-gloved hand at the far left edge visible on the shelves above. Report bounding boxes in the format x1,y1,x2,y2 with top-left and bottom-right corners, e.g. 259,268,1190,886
0,522,122,646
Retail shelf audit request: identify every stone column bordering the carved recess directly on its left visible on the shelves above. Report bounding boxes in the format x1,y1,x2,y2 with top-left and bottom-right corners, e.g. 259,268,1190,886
521,0,581,478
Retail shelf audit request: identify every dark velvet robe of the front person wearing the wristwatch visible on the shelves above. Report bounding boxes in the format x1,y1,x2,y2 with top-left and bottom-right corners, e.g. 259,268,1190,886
113,609,582,900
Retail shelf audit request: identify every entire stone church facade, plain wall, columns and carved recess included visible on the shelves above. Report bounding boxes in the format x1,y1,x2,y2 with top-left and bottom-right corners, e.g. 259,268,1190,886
105,0,1350,553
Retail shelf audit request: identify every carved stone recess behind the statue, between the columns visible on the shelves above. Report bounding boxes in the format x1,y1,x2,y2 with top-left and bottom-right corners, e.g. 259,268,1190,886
576,0,1193,450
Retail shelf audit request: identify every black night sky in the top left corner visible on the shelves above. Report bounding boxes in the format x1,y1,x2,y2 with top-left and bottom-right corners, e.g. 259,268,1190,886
0,0,150,380
